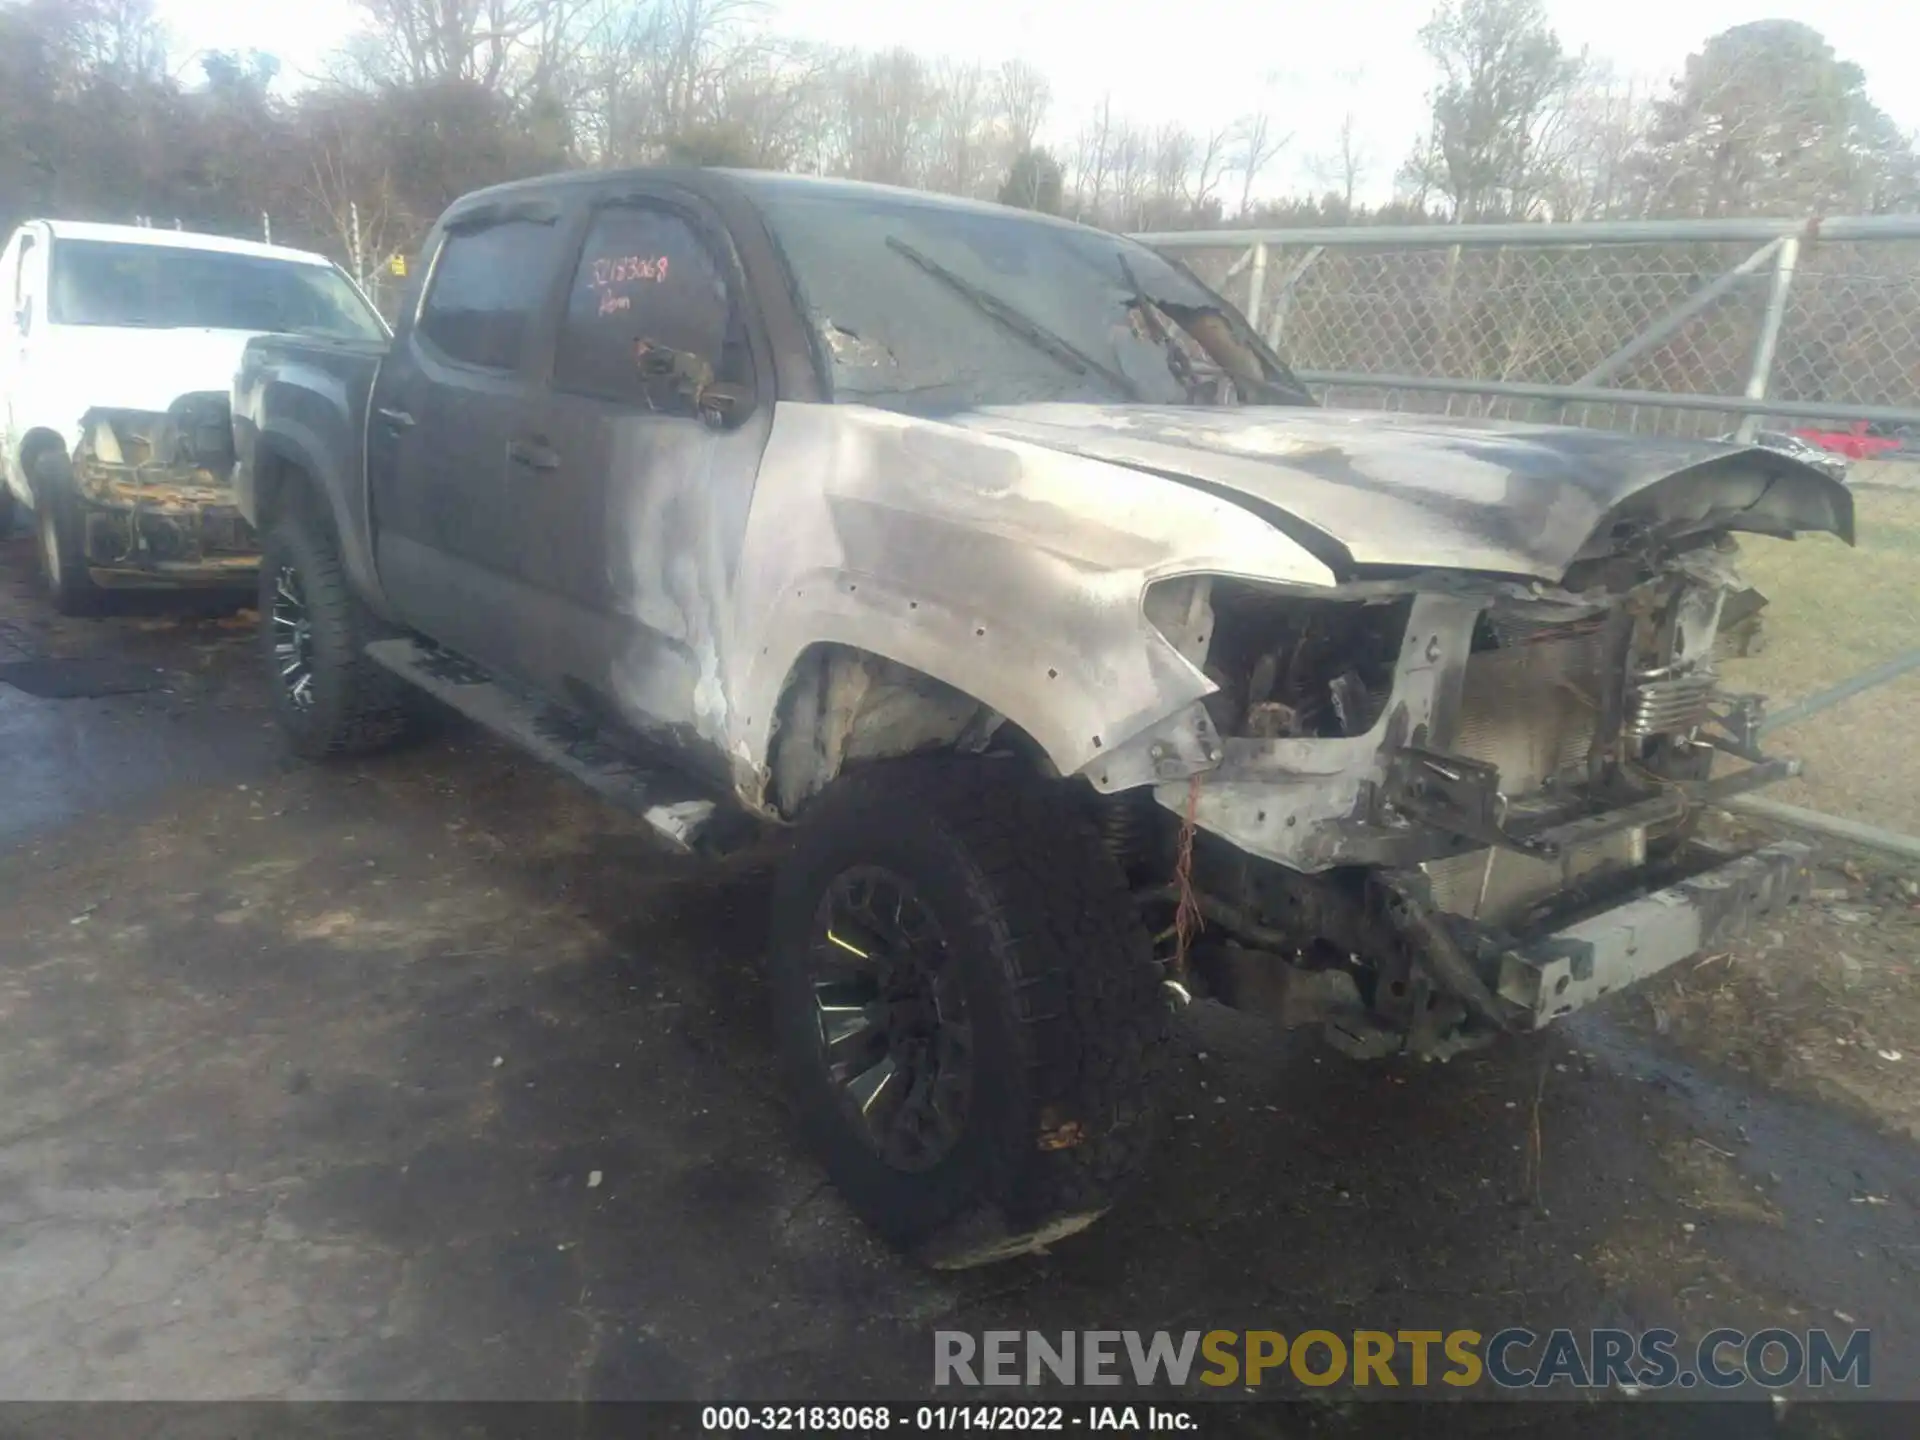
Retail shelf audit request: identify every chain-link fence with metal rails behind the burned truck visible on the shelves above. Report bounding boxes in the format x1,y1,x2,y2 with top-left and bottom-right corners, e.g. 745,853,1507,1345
1142,215,1920,854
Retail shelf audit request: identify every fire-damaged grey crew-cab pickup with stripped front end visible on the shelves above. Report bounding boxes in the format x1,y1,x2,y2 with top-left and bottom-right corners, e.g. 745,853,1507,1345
234,171,1853,1265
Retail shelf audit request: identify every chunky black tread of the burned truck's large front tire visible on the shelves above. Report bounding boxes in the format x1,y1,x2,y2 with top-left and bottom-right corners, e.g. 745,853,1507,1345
771,756,1169,1265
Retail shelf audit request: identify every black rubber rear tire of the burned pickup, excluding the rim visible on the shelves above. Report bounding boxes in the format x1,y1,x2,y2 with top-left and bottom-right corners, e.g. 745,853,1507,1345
259,503,420,760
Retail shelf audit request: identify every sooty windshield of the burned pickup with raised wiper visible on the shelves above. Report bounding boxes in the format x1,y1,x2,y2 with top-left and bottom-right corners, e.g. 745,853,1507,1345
753,177,1313,413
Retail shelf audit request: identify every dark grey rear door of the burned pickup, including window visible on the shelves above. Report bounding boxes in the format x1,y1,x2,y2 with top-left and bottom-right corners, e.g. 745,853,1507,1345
367,205,563,668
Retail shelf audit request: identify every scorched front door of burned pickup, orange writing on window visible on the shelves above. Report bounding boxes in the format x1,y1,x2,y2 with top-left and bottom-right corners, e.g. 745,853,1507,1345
513,192,774,774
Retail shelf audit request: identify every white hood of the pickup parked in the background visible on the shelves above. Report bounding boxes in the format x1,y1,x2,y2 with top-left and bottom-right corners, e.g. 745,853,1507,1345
33,324,253,433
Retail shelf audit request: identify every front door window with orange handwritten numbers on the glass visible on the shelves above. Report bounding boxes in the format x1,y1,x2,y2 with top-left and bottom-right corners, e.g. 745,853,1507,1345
553,204,749,409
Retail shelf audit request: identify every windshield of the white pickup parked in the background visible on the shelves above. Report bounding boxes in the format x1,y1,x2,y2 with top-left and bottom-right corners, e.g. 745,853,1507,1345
48,240,386,340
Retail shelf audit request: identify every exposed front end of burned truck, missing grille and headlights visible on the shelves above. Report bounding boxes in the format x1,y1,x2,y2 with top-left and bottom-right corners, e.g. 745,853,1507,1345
1100,534,1805,1056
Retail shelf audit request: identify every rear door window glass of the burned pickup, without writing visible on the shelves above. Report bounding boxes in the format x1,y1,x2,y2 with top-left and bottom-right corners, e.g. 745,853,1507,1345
415,221,555,371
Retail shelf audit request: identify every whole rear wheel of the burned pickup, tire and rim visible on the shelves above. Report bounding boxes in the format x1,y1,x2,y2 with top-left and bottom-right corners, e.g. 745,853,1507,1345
259,505,419,760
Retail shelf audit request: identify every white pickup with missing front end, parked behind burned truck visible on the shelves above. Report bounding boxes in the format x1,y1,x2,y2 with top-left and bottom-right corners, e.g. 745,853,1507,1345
0,221,386,614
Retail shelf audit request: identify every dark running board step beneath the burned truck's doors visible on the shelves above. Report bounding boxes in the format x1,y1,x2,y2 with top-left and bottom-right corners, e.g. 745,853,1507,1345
367,637,724,852
